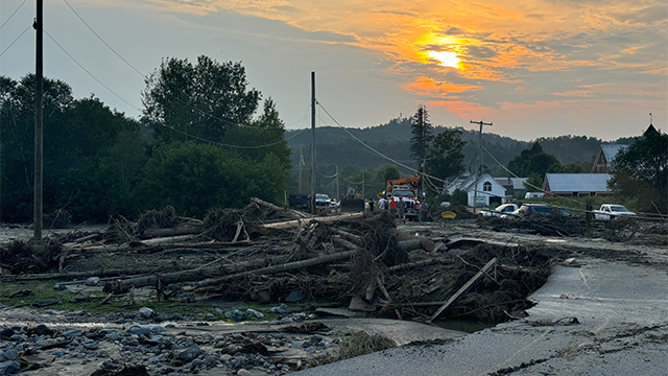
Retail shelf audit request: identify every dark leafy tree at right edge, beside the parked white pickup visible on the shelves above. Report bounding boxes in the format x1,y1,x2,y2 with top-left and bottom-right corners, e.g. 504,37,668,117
608,127,668,214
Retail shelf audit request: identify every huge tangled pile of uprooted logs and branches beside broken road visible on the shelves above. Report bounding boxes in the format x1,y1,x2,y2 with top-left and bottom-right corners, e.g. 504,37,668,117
0,199,550,323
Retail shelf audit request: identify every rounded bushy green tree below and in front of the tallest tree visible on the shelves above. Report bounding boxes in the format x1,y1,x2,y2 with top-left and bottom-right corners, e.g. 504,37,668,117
135,141,288,217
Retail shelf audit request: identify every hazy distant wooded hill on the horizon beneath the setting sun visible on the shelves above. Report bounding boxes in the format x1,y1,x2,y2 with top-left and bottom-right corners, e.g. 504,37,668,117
285,118,633,176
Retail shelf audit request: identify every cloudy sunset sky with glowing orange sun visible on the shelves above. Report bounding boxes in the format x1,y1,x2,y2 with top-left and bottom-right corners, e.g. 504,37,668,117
0,0,668,140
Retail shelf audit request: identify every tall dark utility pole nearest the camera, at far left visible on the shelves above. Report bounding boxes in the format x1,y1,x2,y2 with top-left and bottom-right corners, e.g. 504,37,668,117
33,0,44,240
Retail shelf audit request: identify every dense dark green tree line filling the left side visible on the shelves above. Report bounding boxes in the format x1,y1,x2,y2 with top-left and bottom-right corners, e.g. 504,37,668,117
0,56,290,225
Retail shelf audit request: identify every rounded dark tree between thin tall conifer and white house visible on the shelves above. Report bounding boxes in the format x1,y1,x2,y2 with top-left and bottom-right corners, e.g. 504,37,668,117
426,129,466,179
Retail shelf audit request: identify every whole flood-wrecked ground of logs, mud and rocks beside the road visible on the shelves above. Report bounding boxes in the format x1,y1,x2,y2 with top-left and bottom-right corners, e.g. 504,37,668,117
0,199,668,376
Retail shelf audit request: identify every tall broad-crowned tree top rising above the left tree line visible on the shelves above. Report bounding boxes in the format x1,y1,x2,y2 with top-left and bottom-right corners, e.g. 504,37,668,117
142,55,260,142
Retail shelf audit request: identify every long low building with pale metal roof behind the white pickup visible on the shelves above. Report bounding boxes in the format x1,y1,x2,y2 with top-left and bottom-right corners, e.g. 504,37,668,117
543,173,613,197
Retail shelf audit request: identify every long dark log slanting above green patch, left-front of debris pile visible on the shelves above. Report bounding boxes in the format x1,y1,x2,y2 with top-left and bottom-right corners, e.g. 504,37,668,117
103,255,290,294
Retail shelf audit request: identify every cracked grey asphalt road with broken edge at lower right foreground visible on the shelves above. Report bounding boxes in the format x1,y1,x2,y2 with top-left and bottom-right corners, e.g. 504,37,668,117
294,260,668,376
